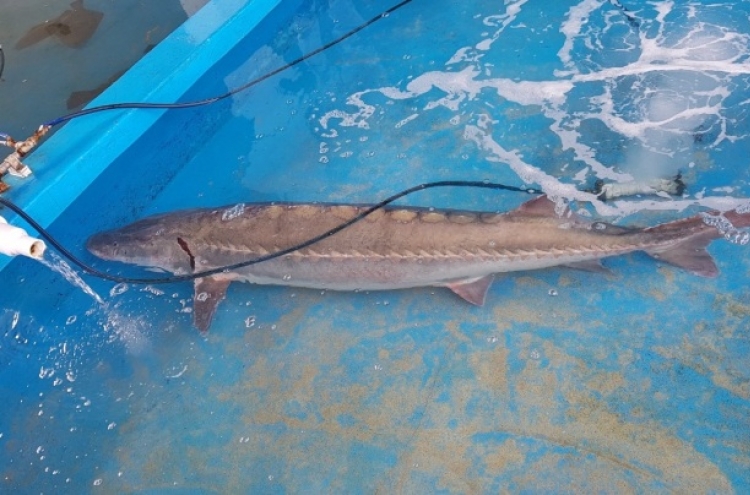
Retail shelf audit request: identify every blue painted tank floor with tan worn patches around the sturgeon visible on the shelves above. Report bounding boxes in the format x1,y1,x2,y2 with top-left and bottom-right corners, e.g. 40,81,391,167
0,0,750,493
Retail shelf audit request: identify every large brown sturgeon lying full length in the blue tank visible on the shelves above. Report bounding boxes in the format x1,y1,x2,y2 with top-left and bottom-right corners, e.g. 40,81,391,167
86,195,750,332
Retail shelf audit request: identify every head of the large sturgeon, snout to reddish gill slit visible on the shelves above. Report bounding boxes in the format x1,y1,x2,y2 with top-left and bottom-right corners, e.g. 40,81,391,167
86,215,192,273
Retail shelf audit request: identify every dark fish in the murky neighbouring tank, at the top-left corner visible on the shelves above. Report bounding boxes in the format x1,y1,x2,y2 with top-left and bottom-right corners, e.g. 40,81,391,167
15,0,104,50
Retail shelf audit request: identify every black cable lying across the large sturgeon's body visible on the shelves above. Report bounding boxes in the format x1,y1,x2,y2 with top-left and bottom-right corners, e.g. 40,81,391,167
0,180,543,284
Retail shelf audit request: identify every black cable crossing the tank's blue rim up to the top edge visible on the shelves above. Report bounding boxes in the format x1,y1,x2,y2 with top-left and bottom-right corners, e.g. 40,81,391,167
44,0,412,127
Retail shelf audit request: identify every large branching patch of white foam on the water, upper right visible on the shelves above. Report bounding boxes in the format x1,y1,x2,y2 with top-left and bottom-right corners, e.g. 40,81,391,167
319,0,750,219
